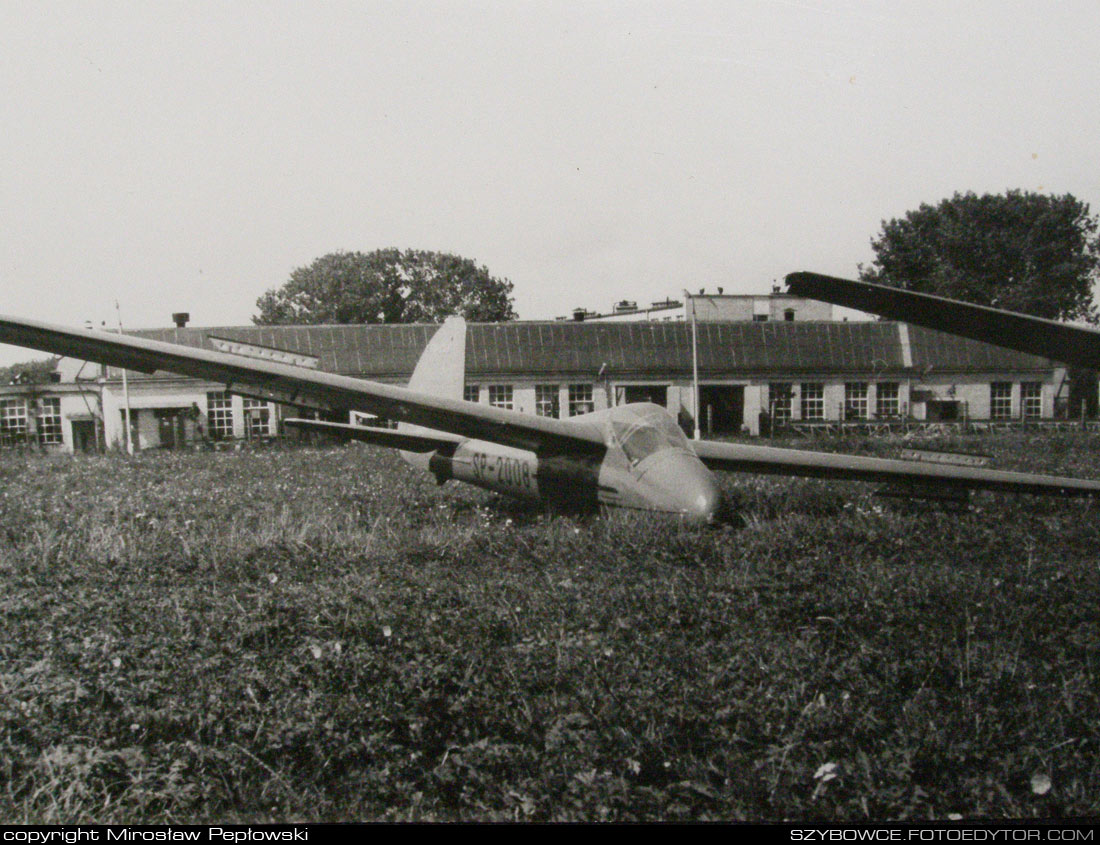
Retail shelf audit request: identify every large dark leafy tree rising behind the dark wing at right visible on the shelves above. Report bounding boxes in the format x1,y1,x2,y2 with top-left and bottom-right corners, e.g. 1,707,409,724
859,190,1100,322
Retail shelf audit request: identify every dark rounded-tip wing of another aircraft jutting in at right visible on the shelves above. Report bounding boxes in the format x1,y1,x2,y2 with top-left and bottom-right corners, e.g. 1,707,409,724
787,272,1100,370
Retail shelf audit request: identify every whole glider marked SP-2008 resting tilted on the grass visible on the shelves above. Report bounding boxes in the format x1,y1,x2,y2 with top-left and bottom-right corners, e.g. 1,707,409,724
0,317,1100,523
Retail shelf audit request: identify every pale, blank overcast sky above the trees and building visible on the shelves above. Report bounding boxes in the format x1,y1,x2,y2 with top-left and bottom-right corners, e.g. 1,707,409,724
0,0,1100,363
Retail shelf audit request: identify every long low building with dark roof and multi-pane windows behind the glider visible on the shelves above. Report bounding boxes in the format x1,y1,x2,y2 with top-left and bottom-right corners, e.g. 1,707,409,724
0,319,1068,451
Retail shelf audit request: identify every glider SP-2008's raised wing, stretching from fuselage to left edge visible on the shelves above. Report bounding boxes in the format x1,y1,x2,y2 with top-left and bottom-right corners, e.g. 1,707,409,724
0,316,605,453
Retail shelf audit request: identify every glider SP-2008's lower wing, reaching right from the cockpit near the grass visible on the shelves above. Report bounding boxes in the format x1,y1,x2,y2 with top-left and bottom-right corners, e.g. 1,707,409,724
692,440,1100,496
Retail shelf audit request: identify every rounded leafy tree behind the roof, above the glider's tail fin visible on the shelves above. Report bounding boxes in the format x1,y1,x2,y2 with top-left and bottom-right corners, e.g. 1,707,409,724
252,249,516,326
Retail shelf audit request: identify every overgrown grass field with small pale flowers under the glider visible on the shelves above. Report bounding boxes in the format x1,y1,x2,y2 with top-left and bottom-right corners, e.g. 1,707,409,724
0,435,1100,823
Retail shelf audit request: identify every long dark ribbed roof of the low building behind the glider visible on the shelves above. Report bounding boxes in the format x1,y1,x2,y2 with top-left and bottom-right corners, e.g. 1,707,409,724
124,321,1052,381
